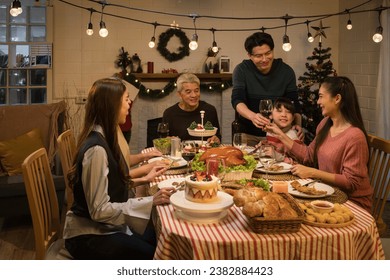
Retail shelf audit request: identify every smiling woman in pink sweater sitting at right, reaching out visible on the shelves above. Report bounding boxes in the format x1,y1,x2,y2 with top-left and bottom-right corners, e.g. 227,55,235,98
266,77,372,212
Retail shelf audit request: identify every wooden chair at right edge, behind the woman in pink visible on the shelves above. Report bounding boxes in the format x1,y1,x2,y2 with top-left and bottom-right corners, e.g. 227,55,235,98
368,135,390,236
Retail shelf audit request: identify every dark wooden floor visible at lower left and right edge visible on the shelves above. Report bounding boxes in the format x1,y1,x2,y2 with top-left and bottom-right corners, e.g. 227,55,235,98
0,201,390,260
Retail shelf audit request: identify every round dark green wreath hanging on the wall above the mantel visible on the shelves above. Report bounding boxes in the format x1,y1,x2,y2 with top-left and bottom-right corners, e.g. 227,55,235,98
157,28,190,62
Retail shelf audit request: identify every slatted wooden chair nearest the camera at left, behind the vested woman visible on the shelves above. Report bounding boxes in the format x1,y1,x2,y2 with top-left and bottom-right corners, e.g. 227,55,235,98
22,148,72,260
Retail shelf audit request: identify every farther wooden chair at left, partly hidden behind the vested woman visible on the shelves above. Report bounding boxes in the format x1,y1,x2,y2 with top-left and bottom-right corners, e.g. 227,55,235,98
57,129,76,210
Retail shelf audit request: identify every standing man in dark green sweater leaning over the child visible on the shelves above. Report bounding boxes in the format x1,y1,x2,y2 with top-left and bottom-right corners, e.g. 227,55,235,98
231,32,304,146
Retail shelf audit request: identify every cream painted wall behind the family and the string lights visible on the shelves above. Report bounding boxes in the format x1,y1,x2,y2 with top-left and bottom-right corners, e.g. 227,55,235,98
53,0,380,152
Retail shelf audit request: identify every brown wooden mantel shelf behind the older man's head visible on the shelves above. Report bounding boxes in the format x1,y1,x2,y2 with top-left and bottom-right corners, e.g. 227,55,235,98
132,73,232,82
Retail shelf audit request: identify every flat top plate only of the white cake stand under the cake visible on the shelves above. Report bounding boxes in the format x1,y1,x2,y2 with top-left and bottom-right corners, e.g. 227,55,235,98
171,191,233,214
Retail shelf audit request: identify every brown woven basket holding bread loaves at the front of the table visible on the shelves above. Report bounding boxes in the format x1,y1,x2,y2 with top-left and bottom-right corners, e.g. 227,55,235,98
247,193,305,234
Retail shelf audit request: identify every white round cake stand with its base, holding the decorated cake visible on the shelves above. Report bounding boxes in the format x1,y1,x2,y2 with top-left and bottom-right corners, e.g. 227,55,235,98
171,191,233,224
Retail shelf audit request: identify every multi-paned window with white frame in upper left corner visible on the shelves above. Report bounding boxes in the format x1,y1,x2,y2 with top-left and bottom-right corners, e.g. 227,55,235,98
0,0,52,106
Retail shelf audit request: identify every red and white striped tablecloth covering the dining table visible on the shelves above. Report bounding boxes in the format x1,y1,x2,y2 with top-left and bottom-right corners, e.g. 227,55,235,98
154,175,385,260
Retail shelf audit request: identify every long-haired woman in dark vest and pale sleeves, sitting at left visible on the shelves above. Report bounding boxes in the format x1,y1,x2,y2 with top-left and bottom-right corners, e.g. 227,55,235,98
64,78,174,259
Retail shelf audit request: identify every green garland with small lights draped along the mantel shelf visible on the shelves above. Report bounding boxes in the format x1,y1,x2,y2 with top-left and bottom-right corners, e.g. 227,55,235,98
119,72,233,99
